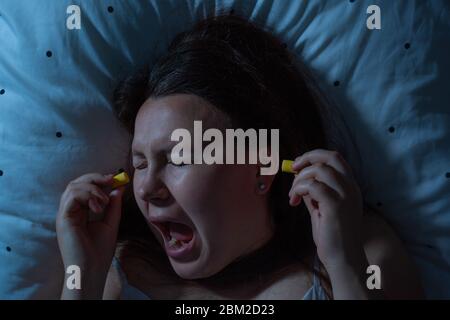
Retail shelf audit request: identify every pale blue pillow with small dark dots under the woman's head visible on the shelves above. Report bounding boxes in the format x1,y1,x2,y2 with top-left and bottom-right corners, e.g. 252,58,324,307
0,0,450,299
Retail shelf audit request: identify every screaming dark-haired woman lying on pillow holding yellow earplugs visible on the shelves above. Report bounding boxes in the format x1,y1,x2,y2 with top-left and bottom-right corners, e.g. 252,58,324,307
57,11,422,299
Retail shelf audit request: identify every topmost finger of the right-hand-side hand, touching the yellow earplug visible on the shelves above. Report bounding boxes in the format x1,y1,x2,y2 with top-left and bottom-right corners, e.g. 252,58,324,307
292,149,353,178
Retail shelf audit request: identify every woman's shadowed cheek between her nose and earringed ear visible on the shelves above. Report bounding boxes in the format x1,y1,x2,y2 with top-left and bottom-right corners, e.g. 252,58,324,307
173,165,256,236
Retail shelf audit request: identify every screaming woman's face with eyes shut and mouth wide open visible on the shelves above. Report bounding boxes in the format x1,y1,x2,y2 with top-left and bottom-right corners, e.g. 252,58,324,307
132,94,273,279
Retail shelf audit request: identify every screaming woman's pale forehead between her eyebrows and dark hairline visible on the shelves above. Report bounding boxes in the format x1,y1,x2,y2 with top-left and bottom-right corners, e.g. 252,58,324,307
133,94,221,149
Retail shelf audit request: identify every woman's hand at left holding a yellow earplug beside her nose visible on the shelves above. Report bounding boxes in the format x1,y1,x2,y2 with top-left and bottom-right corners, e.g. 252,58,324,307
56,173,125,298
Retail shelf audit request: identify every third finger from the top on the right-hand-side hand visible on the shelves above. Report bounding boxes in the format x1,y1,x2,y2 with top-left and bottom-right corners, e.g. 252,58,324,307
291,179,339,210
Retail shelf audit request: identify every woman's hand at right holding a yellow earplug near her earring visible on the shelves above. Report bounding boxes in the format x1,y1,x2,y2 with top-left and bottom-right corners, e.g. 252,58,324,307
289,149,363,268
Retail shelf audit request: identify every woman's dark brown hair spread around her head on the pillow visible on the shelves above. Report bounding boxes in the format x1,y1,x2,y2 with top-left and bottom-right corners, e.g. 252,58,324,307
114,15,344,296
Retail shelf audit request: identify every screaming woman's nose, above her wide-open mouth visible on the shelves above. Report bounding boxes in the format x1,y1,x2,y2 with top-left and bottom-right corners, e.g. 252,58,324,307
138,173,172,207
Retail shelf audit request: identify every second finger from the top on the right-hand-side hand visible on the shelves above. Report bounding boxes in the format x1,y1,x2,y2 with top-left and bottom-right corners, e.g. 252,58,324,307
293,162,347,197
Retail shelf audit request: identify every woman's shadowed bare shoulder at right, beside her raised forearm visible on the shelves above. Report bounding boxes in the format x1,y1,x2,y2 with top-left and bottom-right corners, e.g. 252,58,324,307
363,209,423,299
